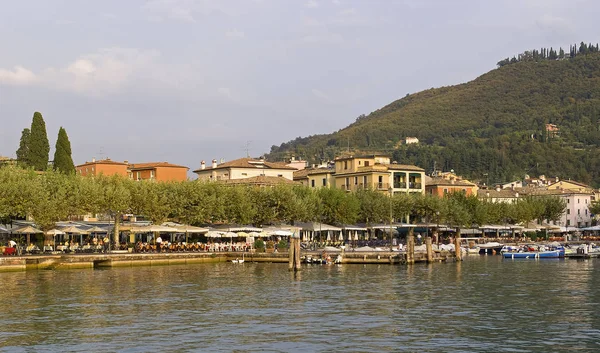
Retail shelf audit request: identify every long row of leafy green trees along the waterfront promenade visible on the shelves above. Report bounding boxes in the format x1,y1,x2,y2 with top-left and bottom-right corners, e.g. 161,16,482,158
0,167,565,241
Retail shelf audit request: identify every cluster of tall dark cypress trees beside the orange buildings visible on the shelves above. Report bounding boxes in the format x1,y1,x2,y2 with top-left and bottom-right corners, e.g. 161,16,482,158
17,112,75,174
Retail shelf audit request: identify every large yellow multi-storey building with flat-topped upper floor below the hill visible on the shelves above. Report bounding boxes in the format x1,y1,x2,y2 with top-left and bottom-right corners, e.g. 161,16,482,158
333,155,425,193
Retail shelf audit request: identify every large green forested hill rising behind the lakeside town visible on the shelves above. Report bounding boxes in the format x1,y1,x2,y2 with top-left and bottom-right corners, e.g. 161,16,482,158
268,46,600,186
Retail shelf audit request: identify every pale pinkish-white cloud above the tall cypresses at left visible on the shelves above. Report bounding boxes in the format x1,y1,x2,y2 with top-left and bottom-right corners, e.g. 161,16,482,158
0,48,160,96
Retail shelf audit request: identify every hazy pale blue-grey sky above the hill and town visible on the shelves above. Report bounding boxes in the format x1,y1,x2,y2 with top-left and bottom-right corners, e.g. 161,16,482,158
0,0,600,169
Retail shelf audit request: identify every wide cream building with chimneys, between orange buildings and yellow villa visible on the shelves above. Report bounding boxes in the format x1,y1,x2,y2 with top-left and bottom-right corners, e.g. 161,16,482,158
194,158,297,181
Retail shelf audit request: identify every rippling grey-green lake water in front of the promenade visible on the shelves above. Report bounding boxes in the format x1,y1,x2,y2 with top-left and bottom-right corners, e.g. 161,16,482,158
0,256,600,352
